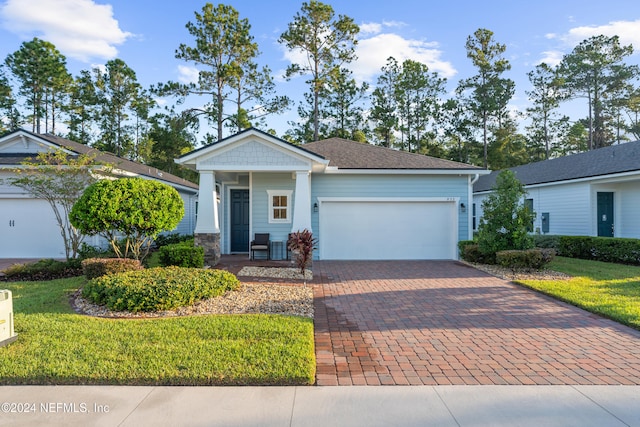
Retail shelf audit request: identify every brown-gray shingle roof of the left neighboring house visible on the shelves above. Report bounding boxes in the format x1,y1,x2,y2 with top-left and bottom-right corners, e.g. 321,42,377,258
0,130,198,190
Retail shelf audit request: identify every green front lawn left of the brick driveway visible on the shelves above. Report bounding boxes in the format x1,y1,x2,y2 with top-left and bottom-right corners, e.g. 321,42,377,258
0,278,315,385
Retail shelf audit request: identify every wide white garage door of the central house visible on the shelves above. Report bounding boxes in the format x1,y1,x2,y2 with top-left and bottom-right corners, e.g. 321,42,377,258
318,200,458,260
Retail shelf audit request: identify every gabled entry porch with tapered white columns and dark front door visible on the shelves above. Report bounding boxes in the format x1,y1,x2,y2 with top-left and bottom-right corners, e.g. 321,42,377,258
176,129,328,265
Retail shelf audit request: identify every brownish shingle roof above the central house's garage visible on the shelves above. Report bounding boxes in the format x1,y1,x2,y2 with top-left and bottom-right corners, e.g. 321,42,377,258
300,138,482,170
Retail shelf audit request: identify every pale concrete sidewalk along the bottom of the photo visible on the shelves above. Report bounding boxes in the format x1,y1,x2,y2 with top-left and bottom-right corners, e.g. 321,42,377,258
0,385,640,427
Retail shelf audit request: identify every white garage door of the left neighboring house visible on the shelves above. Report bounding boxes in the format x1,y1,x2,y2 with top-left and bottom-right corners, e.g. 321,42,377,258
0,199,65,258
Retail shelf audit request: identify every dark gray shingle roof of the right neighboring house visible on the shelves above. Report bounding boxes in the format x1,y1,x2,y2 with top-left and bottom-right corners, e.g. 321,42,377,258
473,141,640,193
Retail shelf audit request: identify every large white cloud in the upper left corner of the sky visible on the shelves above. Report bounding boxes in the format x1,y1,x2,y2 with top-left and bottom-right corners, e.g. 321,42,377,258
0,0,132,62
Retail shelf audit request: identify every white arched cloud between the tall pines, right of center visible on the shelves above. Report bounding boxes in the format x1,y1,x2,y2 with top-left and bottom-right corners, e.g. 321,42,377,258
351,33,457,82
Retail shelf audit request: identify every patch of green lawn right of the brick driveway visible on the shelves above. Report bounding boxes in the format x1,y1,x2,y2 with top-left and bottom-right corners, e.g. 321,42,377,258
518,257,640,329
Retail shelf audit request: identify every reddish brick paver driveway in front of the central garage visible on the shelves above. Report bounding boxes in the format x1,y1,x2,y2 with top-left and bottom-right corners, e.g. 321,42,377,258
313,261,640,385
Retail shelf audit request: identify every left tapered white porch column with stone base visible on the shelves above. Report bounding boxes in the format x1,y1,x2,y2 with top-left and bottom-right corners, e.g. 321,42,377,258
194,171,220,266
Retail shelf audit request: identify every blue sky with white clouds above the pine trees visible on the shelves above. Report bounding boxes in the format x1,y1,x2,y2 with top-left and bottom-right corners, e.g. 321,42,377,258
0,0,640,144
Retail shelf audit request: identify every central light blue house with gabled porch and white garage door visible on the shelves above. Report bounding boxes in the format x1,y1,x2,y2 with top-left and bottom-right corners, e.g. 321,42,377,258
176,129,489,263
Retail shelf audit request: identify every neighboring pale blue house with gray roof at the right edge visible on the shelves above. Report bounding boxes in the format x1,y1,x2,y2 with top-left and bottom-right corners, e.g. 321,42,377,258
473,141,640,238
